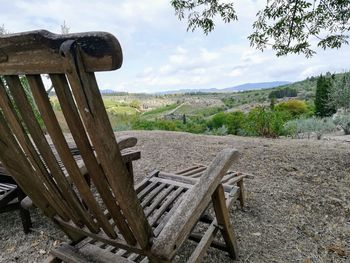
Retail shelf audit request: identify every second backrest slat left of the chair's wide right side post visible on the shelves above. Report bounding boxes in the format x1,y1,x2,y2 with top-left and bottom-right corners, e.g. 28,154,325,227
27,75,112,235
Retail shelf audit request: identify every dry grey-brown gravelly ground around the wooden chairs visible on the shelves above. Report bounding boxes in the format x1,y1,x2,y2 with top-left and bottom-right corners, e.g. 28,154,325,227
0,131,350,263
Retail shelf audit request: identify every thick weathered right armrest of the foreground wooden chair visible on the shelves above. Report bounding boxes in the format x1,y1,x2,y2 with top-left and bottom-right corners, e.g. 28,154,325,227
151,149,239,260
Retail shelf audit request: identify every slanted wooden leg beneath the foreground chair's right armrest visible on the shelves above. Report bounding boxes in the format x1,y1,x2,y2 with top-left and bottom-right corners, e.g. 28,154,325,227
212,184,238,259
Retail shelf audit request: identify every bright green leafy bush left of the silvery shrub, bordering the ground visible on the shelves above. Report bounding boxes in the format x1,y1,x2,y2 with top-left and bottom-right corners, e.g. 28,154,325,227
242,107,291,138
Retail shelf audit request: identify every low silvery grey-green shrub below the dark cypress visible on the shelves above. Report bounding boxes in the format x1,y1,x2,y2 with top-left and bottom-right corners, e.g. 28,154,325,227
284,117,336,140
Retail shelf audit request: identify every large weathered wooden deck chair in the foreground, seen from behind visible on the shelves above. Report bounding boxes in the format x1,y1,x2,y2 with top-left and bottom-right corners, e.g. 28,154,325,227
0,31,238,262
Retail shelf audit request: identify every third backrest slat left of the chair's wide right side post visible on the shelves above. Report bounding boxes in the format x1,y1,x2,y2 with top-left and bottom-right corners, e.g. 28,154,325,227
5,76,82,225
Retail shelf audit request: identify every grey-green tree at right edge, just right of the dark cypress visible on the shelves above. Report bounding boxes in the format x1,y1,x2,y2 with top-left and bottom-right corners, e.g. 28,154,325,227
328,72,350,109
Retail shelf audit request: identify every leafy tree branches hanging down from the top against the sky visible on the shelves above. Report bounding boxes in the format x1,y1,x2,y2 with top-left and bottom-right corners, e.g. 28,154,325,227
171,0,350,57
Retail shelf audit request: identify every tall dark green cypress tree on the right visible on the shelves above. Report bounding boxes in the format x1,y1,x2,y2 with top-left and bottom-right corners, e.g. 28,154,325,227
315,74,335,117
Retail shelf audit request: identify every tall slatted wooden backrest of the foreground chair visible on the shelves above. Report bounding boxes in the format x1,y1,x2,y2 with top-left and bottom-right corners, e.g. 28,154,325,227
0,31,152,248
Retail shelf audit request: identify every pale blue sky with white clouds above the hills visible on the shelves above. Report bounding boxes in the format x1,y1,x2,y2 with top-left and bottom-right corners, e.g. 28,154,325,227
0,0,350,93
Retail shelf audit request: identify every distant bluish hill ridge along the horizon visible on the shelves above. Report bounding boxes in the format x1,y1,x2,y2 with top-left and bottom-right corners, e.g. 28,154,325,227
156,81,291,94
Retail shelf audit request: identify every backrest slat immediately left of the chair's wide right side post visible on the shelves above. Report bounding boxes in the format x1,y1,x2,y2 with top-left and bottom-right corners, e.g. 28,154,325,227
50,74,135,244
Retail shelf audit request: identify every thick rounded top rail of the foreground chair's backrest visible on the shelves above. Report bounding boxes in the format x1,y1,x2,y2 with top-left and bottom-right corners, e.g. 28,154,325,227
0,30,123,75
